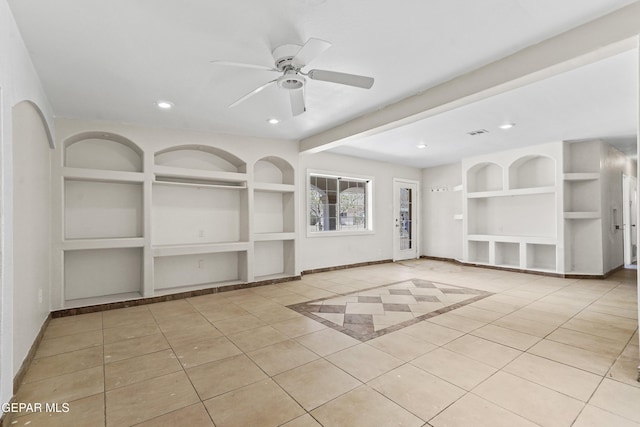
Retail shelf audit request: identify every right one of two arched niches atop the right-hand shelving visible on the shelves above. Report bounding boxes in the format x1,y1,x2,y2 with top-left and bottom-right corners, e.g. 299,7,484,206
509,155,556,189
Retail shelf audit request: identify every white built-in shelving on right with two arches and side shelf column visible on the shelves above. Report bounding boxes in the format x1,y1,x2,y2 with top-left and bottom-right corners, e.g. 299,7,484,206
463,141,605,275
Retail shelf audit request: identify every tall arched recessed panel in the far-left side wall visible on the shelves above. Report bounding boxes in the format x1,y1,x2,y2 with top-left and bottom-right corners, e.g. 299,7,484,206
13,101,51,375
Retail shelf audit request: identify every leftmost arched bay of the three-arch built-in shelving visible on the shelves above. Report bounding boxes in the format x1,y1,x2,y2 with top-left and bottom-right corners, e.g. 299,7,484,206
60,132,145,305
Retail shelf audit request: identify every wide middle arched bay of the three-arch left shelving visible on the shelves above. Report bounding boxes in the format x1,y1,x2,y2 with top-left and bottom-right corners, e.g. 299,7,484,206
151,145,250,293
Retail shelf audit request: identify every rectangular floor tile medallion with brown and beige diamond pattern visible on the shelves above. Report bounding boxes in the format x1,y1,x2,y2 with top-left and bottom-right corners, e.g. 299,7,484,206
288,279,492,342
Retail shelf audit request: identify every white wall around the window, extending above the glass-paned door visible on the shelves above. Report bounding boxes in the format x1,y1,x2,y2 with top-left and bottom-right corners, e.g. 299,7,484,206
298,153,421,271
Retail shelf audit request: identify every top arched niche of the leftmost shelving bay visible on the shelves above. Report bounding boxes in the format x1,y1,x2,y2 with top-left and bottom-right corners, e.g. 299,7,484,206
64,132,143,172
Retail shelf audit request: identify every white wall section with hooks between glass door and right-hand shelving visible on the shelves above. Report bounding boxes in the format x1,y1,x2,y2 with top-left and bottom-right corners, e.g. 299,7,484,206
420,162,462,259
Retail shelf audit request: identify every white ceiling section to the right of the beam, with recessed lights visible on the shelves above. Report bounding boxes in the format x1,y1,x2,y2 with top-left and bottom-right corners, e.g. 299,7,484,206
329,50,638,168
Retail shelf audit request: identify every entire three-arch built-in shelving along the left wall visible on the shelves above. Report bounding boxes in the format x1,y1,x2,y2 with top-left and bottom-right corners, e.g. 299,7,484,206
52,132,299,309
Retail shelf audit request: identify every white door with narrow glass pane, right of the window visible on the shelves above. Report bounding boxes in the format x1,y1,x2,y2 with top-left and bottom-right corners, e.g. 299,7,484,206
393,178,419,261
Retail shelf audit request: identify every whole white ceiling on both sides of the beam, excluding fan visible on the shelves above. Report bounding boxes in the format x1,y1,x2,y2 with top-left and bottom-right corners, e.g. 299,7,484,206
8,0,638,167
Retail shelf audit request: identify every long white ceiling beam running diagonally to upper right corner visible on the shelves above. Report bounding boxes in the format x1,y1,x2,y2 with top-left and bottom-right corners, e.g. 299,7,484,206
300,1,640,153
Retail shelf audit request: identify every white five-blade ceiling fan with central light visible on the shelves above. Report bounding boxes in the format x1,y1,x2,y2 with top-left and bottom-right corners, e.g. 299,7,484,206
211,38,374,116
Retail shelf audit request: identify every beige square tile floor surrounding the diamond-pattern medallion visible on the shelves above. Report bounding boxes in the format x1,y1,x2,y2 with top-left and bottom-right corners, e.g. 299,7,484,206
6,260,640,427
